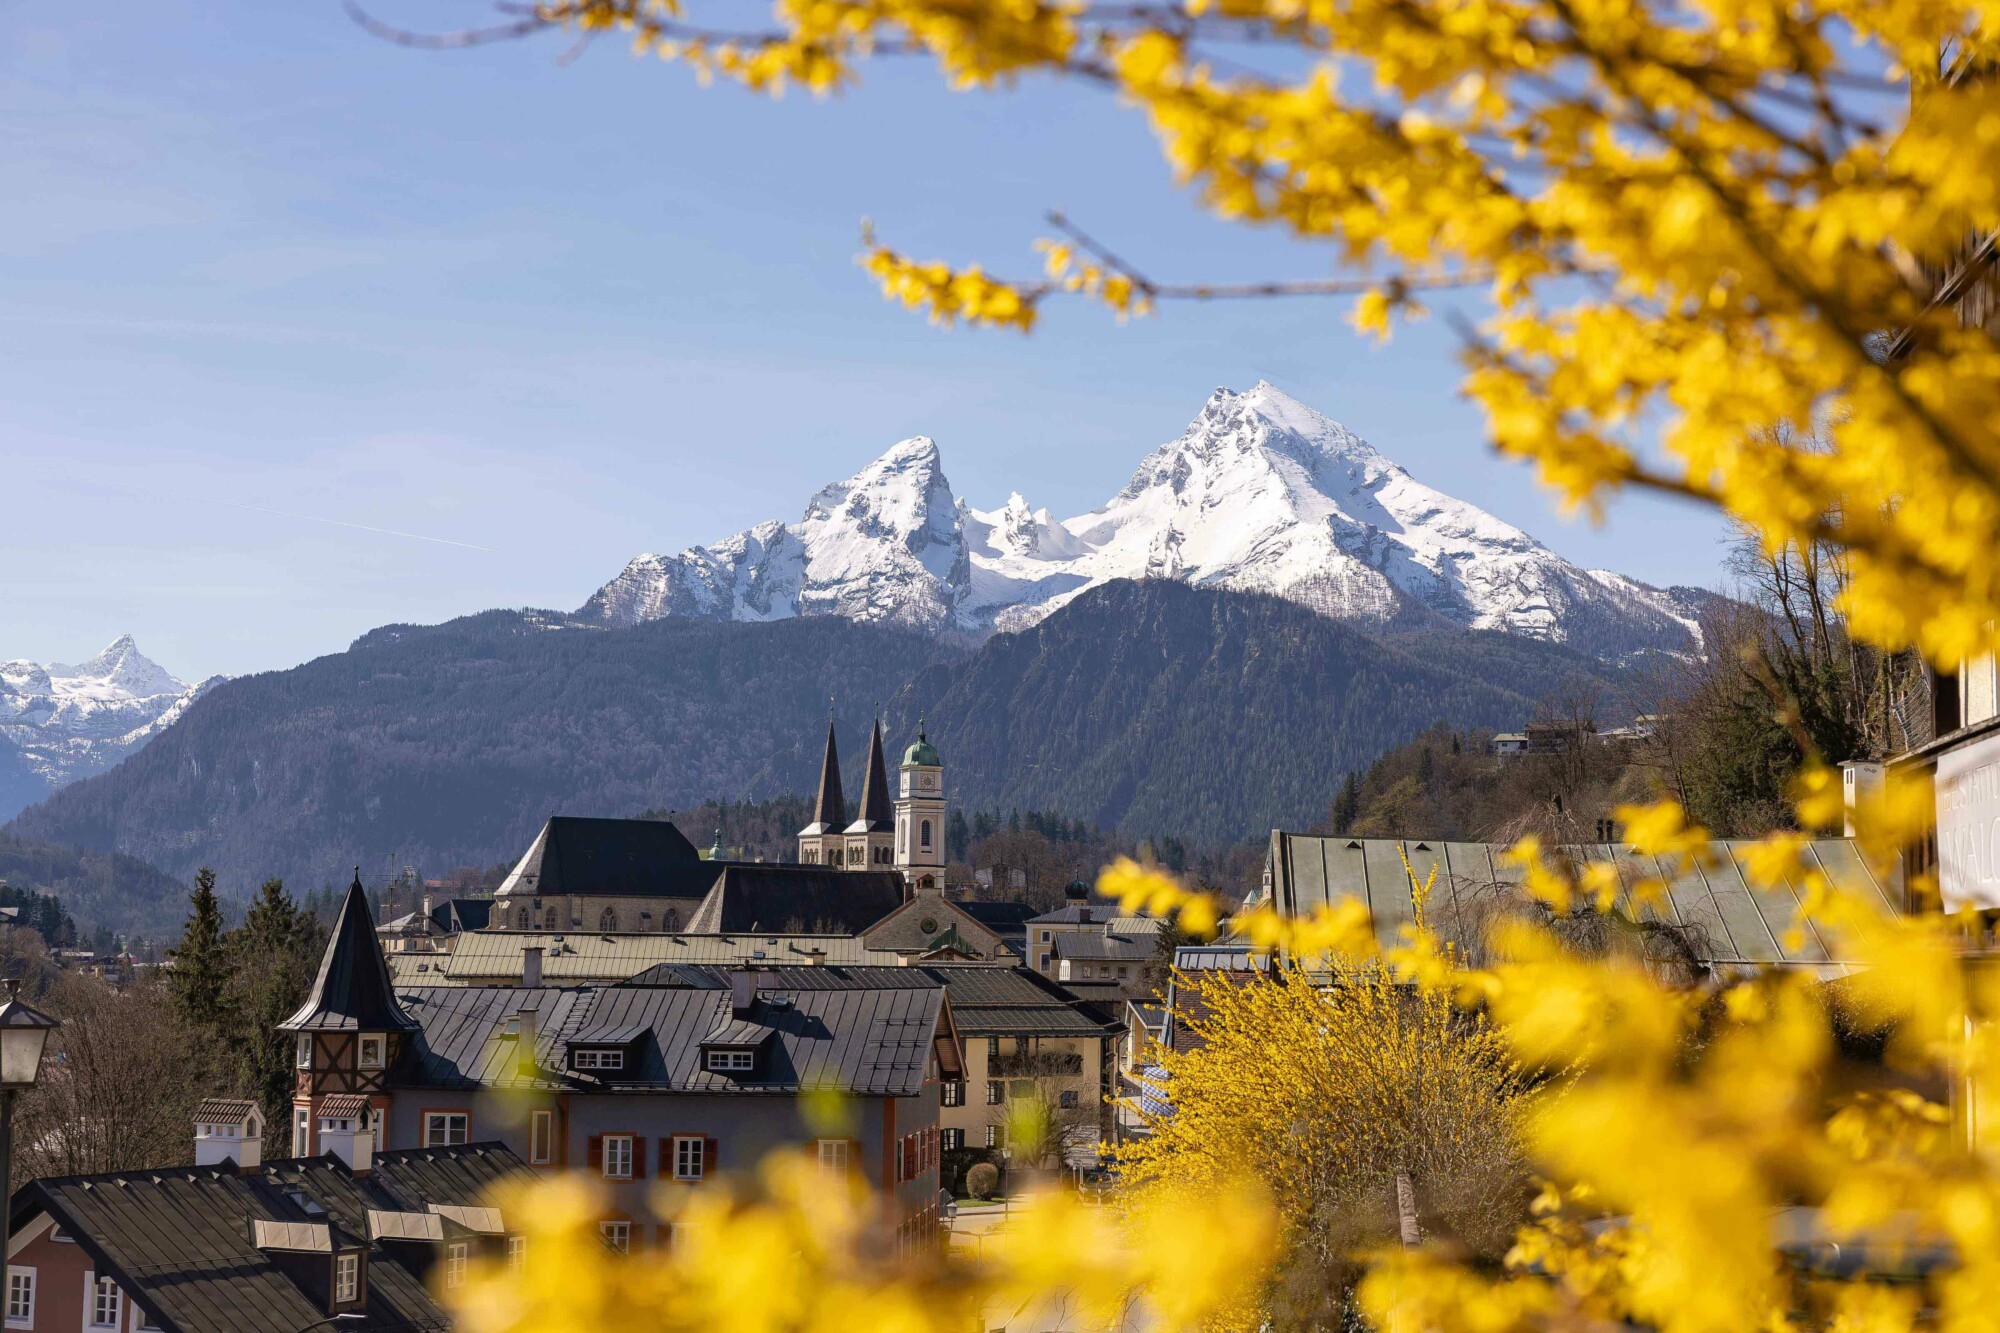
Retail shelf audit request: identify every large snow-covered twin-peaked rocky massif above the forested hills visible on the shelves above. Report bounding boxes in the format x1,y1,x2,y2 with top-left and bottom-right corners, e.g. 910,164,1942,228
580,382,1704,660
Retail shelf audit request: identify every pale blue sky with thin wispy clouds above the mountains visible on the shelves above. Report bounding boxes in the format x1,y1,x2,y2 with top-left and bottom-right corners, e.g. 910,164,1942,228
0,0,1720,677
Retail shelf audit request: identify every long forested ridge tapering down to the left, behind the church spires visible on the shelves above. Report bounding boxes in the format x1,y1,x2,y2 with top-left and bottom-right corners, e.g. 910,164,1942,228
12,610,946,893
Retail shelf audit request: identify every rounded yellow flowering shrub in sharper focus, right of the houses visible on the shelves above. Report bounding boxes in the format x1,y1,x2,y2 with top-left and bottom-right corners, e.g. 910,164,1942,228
1118,959,1530,1329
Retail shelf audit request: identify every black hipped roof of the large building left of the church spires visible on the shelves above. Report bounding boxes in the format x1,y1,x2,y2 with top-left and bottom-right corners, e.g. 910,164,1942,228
496,815,714,899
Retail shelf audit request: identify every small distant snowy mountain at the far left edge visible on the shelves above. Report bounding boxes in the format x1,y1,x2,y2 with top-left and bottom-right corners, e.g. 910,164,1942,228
0,634,222,819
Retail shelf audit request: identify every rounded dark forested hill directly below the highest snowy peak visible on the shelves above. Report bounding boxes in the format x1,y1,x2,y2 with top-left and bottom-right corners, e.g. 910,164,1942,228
896,580,1610,843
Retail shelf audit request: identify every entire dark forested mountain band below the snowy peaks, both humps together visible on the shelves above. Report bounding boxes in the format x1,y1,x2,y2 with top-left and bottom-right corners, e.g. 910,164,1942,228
12,580,1632,895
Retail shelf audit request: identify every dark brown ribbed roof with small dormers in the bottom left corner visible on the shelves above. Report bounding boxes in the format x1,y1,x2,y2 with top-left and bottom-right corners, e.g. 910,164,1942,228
12,1143,526,1333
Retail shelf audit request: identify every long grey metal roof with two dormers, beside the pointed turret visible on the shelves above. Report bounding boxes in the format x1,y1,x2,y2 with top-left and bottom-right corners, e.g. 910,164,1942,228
396,967,944,1097
